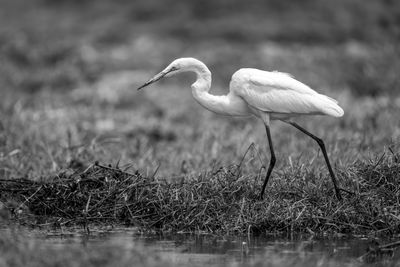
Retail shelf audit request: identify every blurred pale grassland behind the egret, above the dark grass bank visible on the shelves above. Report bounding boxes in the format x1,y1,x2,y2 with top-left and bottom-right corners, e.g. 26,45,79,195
0,0,400,178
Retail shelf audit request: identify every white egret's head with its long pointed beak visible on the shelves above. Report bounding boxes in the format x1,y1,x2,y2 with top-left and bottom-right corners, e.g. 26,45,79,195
138,58,202,90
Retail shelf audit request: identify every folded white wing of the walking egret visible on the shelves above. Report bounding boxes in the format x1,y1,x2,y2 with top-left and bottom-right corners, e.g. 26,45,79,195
231,69,343,117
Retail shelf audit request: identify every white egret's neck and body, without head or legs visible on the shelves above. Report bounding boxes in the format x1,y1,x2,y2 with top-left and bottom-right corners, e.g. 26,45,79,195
163,59,343,120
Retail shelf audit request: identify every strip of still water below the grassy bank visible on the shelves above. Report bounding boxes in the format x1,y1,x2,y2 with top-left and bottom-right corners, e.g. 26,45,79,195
7,228,400,267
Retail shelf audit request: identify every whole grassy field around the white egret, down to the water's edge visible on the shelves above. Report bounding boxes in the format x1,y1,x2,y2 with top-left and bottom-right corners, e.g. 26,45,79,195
0,0,400,266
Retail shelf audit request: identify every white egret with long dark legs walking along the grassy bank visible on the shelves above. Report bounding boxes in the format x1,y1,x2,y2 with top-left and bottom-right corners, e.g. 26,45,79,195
137,57,344,201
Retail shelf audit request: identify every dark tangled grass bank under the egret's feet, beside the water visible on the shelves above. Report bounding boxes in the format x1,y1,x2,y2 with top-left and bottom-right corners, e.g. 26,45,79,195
0,153,400,236
